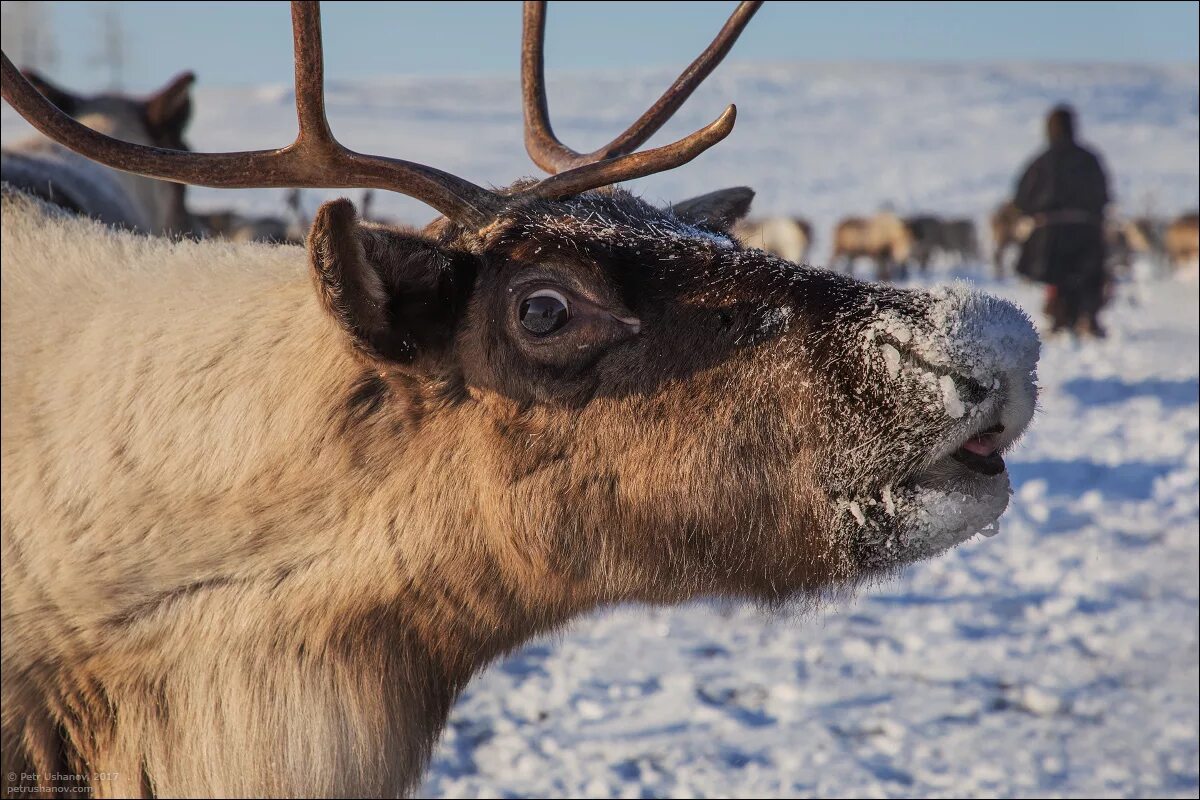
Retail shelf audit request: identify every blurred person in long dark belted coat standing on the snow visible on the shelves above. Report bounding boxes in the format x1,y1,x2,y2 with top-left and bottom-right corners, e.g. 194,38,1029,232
1013,106,1109,336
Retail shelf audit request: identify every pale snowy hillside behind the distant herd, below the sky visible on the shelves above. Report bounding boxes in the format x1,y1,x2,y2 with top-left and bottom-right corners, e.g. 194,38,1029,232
2,64,1200,259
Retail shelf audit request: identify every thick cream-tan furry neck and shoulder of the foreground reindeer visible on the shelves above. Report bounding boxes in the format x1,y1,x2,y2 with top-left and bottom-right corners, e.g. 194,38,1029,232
4,205,595,796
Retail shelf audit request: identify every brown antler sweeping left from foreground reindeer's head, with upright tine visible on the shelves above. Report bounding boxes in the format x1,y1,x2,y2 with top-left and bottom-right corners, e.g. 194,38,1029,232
0,0,506,228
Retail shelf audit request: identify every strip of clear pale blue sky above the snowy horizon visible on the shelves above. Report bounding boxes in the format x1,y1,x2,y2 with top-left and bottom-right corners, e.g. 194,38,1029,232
28,0,1200,90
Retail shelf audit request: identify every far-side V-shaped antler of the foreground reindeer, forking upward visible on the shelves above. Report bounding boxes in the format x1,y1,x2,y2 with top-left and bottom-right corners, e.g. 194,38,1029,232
521,0,762,173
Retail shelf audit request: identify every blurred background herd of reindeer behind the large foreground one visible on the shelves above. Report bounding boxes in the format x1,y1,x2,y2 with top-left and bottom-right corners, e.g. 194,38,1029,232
2,72,1200,281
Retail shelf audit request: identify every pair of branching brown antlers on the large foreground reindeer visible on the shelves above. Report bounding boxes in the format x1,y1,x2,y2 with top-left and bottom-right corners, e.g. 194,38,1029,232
0,0,761,229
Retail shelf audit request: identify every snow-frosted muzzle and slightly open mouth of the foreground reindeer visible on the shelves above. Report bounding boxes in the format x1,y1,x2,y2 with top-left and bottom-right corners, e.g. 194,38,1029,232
836,281,1039,572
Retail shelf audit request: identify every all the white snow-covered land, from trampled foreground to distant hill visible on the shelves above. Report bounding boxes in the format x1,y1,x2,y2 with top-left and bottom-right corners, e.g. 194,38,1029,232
2,64,1200,796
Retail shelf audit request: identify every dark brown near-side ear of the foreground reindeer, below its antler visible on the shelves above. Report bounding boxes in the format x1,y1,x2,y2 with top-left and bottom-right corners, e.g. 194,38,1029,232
308,199,474,367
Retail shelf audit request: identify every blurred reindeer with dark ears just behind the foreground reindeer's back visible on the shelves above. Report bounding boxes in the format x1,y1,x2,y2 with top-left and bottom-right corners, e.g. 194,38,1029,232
0,72,196,235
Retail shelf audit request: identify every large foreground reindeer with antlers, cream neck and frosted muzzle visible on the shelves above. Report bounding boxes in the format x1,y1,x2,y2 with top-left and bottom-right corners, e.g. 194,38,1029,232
0,2,1038,796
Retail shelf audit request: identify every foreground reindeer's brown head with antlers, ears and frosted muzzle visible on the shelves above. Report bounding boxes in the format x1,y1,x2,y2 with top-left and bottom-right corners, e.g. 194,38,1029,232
4,4,1038,601
